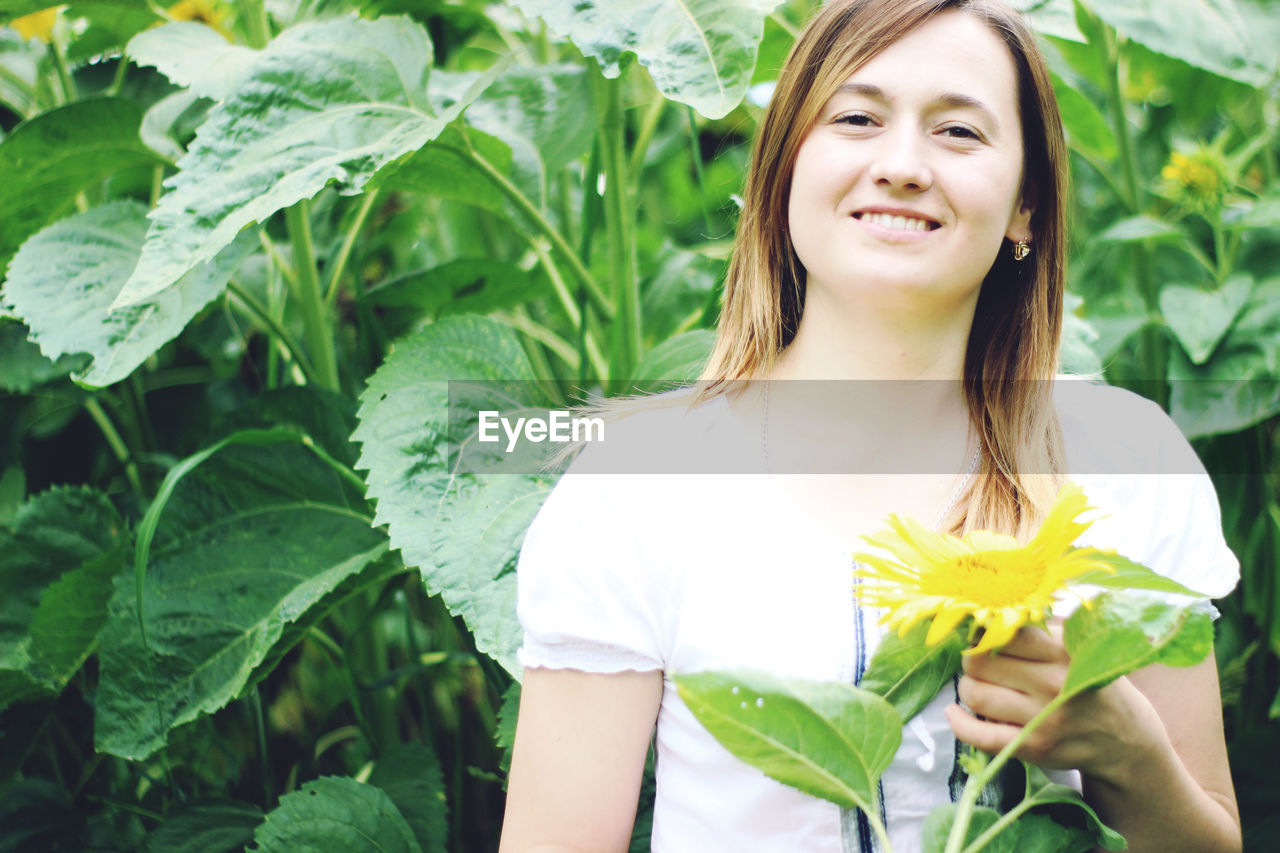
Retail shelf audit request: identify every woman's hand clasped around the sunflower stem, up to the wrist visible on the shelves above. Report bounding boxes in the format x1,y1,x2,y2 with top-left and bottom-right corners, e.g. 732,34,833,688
946,624,1161,779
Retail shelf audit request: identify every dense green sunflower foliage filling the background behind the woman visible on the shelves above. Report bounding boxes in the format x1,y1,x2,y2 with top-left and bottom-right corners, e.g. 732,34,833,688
0,0,1280,852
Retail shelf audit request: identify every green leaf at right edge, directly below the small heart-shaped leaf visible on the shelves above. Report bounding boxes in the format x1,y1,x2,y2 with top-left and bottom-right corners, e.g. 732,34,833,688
1169,278,1280,438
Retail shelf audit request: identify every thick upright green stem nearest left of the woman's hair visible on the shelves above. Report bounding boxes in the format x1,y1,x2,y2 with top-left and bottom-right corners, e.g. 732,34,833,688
600,77,640,392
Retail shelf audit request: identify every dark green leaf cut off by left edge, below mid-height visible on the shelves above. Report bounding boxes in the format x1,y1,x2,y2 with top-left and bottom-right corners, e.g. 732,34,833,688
0,488,128,707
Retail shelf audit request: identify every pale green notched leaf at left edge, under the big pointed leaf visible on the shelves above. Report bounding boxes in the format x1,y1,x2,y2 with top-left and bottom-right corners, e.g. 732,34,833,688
4,201,255,386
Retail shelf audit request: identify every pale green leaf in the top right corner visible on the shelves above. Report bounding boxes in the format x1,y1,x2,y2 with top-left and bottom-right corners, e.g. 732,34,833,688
1087,0,1276,86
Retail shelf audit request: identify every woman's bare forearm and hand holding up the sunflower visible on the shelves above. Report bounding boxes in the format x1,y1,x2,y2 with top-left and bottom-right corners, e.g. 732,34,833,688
947,629,1240,853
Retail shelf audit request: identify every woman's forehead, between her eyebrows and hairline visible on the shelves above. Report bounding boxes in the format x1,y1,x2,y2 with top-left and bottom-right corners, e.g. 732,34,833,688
829,10,1018,118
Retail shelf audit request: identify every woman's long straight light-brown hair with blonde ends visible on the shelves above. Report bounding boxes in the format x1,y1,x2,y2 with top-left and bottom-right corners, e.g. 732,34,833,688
701,0,1068,537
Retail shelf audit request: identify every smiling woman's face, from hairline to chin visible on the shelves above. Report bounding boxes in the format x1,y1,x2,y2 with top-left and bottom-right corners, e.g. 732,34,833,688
787,12,1032,309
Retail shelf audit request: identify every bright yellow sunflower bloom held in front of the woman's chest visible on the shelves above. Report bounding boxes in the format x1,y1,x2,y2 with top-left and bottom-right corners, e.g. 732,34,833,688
854,483,1114,654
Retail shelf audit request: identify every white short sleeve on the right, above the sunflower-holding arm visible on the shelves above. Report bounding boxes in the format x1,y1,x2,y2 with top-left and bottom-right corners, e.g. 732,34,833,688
1064,388,1240,616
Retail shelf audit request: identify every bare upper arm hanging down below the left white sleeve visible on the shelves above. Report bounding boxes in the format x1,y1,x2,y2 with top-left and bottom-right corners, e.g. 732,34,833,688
499,669,662,853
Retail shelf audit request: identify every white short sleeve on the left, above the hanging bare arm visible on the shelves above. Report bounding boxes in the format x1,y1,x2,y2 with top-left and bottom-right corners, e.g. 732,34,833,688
517,469,664,672
